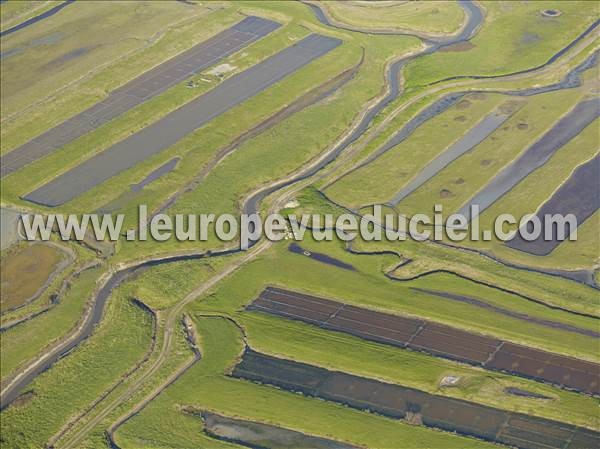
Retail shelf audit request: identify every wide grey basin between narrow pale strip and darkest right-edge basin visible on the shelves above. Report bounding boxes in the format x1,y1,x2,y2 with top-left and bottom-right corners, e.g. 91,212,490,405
457,98,600,219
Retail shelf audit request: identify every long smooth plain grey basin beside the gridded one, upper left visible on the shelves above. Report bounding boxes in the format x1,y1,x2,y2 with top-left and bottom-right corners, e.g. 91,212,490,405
24,34,342,207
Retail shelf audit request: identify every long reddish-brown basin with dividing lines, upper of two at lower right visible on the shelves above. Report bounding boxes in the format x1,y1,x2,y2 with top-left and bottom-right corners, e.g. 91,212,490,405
246,287,600,395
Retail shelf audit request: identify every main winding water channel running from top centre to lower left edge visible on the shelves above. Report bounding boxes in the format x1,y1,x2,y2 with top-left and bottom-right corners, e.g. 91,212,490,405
0,1,591,409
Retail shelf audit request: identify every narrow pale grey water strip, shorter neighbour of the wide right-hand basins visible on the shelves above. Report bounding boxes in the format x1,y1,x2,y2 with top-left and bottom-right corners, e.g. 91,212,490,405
389,110,511,206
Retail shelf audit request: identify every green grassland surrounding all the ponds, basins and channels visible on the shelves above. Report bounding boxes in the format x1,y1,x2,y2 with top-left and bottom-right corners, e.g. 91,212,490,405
0,0,600,449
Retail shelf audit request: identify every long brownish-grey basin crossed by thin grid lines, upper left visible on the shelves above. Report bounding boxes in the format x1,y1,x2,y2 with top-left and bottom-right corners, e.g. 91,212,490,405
0,16,279,177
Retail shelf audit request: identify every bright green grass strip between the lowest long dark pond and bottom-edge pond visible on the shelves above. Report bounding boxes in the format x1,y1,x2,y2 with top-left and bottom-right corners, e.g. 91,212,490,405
117,317,491,448
